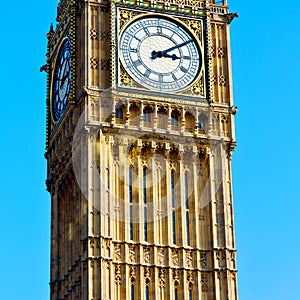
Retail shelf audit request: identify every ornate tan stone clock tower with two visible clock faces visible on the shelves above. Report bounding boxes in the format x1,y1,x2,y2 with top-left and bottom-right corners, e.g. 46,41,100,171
43,0,238,300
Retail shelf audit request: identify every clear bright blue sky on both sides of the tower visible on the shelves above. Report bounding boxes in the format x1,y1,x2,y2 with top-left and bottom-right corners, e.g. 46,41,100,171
0,0,300,300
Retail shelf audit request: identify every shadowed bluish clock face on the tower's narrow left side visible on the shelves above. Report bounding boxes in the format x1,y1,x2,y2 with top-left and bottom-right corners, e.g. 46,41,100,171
52,39,71,122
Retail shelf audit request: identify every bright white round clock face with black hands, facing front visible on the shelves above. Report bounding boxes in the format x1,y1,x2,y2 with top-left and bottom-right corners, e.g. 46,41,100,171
119,17,201,92
